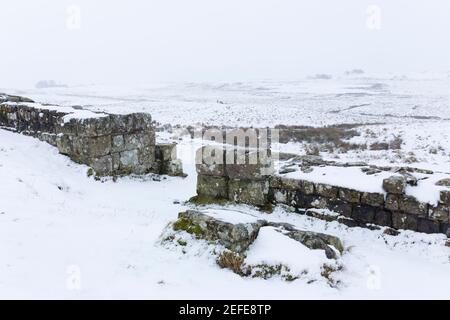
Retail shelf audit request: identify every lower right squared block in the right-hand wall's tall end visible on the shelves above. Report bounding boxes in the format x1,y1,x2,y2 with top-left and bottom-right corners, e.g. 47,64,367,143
228,179,269,206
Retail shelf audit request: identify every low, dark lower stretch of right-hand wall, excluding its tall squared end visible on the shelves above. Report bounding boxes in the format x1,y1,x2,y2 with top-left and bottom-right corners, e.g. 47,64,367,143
269,176,450,233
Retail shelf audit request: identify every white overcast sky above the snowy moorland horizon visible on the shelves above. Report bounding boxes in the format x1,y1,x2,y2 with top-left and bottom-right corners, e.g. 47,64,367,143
0,0,450,87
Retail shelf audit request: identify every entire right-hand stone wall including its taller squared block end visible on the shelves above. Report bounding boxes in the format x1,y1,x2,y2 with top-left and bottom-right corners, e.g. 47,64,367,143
197,147,450,236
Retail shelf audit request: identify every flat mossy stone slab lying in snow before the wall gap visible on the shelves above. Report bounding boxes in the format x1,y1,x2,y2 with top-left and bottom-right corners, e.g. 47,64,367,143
173,210,266,253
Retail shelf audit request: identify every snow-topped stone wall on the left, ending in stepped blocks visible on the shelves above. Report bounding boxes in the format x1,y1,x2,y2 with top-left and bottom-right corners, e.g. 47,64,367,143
0,95,182,176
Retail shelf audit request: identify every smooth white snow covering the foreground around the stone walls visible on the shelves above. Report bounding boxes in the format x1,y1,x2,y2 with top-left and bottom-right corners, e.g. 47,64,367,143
0,129,450,299
